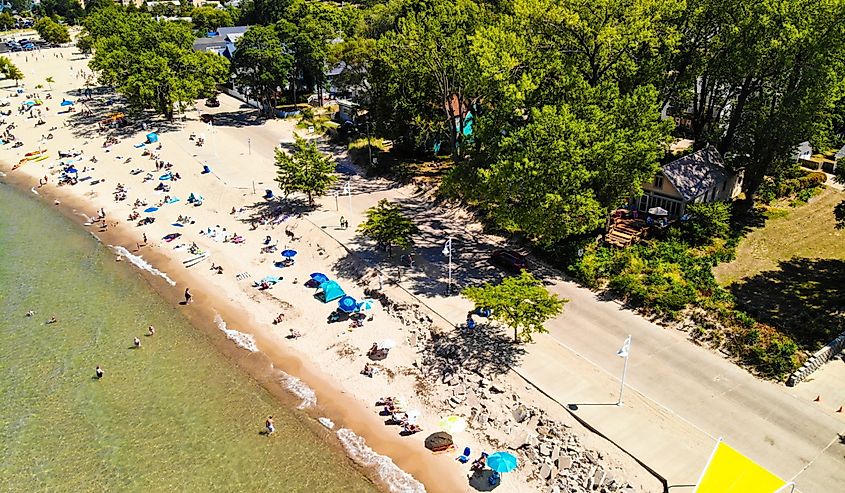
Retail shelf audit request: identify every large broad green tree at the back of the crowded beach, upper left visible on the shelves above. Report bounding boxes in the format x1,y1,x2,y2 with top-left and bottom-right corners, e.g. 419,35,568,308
87,9,229,119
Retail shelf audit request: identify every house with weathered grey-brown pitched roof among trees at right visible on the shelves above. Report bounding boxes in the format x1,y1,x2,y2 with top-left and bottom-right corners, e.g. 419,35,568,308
632,146,743,216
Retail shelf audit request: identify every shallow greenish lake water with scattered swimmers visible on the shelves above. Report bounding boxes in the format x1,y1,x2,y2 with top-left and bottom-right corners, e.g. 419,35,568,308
0,183,376,493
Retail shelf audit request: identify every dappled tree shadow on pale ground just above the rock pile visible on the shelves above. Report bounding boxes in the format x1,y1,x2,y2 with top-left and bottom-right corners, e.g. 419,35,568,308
423,324,525,375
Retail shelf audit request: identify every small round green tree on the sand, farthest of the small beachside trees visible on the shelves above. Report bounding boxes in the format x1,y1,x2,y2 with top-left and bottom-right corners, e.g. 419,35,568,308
276,136,337,206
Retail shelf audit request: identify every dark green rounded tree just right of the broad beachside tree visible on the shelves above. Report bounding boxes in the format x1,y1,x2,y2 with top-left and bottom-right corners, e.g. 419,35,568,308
232,26,293,115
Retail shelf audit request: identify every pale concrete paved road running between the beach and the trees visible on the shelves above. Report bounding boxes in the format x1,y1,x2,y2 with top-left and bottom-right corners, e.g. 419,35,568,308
193,91,845,493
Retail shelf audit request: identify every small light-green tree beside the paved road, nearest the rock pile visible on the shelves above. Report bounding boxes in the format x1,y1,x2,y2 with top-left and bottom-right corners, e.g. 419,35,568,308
463,271,568,342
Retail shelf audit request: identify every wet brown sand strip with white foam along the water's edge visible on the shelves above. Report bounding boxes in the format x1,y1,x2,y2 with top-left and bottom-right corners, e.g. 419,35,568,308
0,169,462,493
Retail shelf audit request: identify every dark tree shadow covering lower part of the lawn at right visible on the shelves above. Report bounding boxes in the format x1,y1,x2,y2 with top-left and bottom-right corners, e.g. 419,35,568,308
730,258,845,350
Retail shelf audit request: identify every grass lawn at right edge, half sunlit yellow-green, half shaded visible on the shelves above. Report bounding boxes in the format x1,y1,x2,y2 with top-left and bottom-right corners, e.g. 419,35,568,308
714,185,845,351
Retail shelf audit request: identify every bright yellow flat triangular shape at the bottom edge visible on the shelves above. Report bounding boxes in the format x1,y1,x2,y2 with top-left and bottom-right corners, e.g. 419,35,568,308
694,439,787,493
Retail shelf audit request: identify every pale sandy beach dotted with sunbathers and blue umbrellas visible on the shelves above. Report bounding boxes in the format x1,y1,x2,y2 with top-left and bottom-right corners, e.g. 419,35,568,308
0,42,660,493
